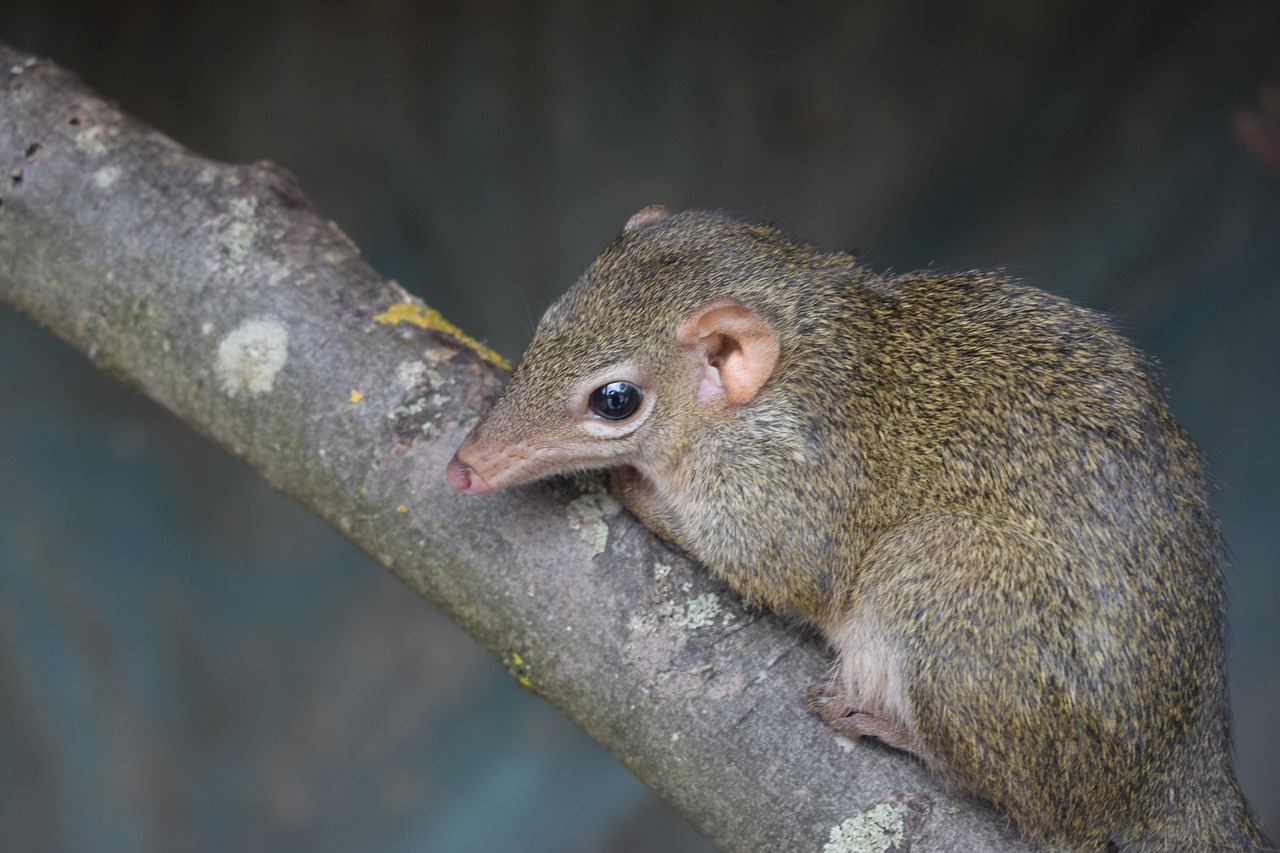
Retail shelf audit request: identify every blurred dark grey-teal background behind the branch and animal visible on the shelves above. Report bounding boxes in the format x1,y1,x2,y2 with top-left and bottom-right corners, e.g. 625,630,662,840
0,0,1280,852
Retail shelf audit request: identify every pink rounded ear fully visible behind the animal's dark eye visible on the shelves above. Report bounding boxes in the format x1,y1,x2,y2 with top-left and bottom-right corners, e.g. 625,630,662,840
678,300,781,406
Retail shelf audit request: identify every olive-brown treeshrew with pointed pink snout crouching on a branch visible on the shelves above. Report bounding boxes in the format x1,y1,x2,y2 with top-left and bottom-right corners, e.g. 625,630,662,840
447,205,1267,852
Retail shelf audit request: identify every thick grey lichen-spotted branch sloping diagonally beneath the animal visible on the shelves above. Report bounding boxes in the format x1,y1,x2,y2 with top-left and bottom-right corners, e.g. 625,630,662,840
0,45,1032,850
